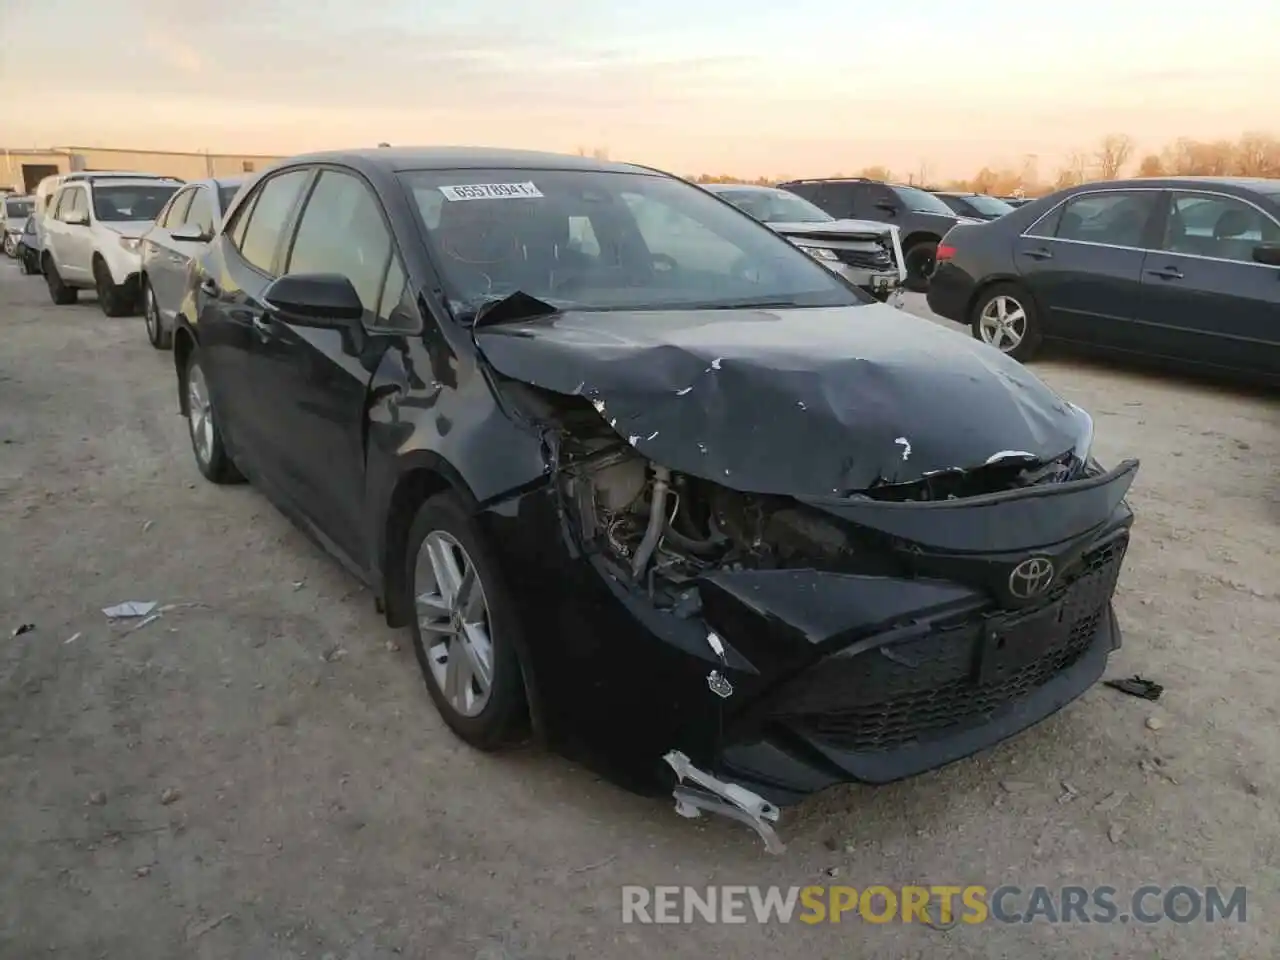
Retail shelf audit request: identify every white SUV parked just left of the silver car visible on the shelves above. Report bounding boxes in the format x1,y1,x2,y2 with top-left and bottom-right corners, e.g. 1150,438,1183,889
41,174,182,316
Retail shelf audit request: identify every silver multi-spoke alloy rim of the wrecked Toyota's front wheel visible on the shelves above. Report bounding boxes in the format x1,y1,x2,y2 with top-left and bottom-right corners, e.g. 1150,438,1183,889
413,530,494,717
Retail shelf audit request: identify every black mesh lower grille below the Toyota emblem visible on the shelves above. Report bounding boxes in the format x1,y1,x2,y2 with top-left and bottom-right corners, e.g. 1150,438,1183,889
772,538,1128,751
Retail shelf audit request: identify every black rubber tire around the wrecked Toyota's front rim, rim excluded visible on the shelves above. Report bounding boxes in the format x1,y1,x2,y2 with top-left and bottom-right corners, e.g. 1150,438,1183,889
404,493,529,751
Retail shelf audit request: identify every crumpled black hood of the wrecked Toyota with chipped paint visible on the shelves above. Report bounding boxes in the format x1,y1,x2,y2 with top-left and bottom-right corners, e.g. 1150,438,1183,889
475,303,1082,497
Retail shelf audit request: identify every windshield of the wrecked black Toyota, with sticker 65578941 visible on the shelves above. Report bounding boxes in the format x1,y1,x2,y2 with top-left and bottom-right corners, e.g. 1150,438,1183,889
402,170,868,315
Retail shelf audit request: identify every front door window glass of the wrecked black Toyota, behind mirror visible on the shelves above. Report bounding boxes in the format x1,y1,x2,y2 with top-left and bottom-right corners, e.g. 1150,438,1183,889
284,170,392,314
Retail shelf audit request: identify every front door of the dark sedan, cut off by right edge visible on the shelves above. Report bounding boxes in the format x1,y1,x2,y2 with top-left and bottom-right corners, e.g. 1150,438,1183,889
1142,191,1280,374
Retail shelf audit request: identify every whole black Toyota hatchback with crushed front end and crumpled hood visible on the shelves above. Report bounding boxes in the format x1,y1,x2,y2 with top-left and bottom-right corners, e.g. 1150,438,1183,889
174,148,1138,849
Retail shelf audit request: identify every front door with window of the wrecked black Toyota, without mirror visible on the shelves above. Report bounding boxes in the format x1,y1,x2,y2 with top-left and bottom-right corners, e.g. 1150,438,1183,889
250,168,421,568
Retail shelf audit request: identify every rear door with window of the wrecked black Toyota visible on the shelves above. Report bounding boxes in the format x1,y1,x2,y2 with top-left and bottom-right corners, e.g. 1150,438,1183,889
193,166,314,481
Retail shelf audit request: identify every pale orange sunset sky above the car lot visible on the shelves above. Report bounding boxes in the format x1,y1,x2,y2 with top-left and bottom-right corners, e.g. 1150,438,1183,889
0,0,1280,178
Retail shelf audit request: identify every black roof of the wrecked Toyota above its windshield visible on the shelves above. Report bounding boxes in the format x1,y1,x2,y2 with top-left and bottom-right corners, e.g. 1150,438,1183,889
267,147,650,175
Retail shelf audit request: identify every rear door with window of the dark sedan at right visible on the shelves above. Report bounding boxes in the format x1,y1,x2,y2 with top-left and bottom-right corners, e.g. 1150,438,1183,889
1014,189,1161,349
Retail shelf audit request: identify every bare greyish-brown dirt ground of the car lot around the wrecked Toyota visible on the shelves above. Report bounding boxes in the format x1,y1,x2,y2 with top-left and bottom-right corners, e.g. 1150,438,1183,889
0,262,1280,960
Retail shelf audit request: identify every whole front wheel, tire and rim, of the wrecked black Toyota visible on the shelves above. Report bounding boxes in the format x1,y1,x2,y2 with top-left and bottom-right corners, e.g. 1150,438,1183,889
404,494,529,750
